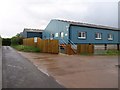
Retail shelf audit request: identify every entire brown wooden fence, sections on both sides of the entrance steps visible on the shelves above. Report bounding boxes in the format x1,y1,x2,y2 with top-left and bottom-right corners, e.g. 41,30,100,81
23,38,94,55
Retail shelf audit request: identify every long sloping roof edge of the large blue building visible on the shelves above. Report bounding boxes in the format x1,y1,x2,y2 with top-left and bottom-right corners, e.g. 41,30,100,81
54,19,119,30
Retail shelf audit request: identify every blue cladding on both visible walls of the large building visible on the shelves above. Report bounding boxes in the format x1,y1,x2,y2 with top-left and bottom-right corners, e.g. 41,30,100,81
43,20,120,44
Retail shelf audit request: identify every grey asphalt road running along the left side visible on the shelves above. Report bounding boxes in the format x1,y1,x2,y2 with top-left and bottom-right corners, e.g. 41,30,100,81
2,46,63,88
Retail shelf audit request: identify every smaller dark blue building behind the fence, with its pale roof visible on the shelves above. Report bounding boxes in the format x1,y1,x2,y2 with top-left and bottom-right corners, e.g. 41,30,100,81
21,28,43,38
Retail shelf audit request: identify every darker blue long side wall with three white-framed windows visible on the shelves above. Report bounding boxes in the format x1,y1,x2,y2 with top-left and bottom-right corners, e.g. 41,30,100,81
70,26,118,44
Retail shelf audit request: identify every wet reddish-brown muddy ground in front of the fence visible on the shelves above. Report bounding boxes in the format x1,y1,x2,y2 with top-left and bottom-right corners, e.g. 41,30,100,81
19,52,118,88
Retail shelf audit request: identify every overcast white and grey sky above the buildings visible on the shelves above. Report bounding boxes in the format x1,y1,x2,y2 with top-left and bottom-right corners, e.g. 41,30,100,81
0,0,119,38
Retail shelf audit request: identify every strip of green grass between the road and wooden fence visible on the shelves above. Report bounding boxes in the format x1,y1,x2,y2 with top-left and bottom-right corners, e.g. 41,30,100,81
12,45,40,52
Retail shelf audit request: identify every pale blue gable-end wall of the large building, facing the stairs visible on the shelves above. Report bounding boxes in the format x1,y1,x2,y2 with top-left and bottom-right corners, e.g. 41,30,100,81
43,20,69,42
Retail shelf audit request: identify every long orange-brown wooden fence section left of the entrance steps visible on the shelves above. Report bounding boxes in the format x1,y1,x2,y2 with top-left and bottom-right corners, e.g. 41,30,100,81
23,38,59,54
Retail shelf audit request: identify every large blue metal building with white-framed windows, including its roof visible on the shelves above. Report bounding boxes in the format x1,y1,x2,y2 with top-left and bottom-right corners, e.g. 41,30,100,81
43,19,120,44
